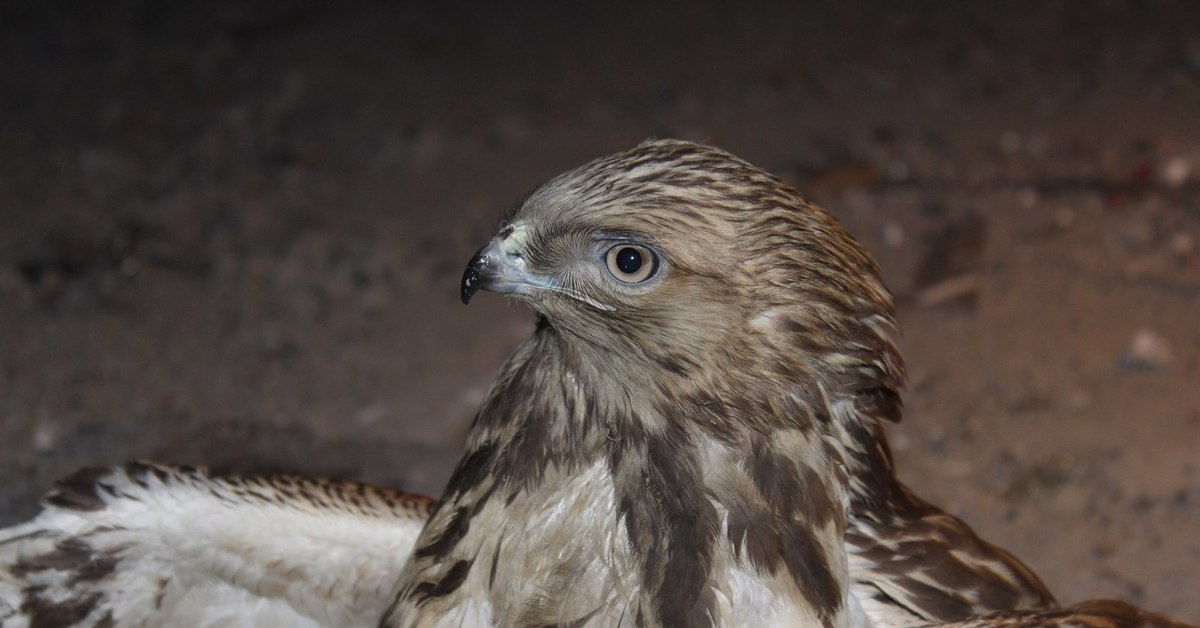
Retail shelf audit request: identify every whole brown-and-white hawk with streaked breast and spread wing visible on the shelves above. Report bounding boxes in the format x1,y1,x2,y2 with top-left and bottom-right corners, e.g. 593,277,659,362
0,140,1190,628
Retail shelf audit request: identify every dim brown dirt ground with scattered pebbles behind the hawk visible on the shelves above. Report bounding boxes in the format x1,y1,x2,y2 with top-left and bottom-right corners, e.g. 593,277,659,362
0,0,1200,623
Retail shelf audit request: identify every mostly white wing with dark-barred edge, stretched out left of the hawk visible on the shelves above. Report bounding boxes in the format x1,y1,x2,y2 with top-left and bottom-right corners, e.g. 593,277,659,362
0,463,433,628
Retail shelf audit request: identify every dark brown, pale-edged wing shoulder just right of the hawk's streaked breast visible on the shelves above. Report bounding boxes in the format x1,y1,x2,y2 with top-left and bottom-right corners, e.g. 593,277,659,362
846,482,1057,626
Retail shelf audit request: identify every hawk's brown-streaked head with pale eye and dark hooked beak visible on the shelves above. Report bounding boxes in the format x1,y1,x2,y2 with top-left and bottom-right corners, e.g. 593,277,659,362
462,140,902,425
